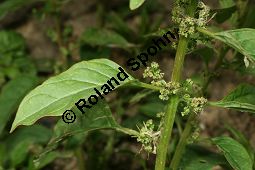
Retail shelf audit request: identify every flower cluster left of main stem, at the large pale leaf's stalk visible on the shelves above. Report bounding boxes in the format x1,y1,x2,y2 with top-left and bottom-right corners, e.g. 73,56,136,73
143,62,181,100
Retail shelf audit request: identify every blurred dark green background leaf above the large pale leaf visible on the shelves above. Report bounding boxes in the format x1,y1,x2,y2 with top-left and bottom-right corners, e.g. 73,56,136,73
81,28,133,48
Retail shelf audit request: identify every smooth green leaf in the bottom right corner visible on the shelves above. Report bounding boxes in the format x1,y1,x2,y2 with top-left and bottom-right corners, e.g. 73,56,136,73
212,137,253,170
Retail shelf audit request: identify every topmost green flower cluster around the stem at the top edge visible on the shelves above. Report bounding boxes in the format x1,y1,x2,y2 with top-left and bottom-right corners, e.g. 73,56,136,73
172,0,210,37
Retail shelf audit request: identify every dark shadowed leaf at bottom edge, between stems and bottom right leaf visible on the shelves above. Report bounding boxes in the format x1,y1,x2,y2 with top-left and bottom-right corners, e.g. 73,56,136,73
179,145,226,170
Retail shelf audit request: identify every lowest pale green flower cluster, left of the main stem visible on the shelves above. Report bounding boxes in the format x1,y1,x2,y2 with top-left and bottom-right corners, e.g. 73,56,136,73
135,119,160,154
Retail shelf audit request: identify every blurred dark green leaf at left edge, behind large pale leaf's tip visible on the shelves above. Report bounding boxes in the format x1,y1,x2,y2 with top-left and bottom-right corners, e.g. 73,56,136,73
0,75,37,134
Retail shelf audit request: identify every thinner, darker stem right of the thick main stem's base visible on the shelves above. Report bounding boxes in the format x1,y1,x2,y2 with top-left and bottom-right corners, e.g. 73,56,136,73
170,113,196,170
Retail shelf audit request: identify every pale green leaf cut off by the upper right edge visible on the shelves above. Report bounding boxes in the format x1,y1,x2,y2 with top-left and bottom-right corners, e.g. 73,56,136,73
213,28,255,62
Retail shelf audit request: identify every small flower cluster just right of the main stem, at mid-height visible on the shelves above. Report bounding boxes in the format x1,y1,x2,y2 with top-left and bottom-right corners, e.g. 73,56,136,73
181,94,207,116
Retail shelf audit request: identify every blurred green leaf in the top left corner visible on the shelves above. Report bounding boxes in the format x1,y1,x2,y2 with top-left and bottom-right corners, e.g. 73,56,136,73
0,0,40,20
